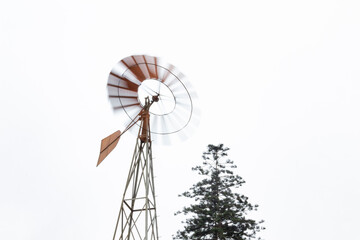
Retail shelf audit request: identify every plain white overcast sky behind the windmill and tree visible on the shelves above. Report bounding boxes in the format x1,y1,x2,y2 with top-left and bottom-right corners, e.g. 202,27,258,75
0,0,360,240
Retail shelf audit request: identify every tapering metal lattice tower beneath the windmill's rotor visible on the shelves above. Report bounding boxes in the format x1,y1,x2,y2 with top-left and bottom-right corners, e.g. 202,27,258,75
113,132,158,240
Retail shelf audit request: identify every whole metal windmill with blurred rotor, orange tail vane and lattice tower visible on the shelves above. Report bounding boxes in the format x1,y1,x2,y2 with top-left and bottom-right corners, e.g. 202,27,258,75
97,55,199,240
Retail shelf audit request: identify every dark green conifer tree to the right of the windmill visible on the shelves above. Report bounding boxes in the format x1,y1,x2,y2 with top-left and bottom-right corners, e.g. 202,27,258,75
174,144,264,240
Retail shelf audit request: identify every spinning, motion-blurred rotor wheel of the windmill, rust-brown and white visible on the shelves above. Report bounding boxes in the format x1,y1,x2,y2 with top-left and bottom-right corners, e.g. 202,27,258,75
107,55,199,142
